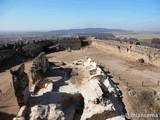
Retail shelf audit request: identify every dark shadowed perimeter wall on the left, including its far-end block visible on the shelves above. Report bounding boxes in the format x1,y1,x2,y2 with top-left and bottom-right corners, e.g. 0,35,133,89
0,38,81,63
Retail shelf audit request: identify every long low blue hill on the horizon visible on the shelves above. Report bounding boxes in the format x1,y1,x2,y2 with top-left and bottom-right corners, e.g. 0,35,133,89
48,28,128,34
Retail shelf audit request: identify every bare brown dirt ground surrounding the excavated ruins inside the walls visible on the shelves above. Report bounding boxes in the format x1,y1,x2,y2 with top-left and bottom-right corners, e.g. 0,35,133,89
0,46,160,120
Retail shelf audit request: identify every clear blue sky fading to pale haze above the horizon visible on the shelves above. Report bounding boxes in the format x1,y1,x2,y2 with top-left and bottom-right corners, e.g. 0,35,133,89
0,0,160,31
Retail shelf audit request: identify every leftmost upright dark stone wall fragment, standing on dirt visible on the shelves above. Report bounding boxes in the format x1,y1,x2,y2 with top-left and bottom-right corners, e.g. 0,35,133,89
10,64,29,107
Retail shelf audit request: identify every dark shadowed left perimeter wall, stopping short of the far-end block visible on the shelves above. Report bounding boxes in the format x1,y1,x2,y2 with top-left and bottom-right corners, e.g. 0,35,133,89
0,40,54,63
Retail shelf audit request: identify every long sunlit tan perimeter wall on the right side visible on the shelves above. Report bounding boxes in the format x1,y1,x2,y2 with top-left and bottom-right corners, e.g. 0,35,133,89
92,40,160,66
